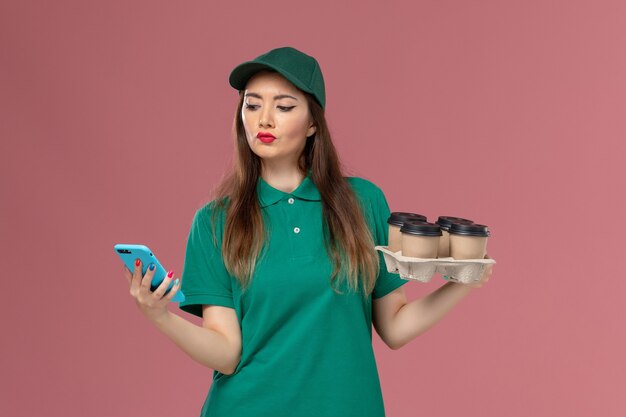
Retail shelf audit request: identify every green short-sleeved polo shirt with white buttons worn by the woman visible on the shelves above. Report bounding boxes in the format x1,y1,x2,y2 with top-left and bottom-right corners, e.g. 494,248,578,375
179,171,408,417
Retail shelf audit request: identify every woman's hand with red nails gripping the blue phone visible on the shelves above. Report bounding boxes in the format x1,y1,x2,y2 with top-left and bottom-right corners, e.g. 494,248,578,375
124,259,180,322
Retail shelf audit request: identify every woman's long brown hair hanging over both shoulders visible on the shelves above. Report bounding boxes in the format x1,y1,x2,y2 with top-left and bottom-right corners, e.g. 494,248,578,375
207,83,379,297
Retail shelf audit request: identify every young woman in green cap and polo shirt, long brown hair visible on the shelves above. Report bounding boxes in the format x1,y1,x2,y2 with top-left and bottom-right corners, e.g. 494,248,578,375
126,47,491,417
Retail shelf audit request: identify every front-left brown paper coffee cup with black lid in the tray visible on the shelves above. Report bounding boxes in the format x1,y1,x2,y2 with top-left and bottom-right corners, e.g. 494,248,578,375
400,221,441,259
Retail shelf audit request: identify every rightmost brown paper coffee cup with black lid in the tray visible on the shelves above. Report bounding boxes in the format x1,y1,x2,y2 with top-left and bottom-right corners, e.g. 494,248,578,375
448,223,490,259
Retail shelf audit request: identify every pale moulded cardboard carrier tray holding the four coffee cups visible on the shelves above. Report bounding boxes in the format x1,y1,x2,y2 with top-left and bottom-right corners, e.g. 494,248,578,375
374,246,496,284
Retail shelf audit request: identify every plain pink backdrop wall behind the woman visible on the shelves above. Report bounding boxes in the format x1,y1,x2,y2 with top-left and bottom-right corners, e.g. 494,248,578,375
0,0,626,417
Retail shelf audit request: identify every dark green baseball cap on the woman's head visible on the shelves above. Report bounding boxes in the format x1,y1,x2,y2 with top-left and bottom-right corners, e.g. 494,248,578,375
228,46,326,108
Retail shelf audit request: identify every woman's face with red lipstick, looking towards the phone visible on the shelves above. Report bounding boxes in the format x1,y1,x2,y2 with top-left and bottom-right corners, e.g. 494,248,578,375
241,71,316,165
